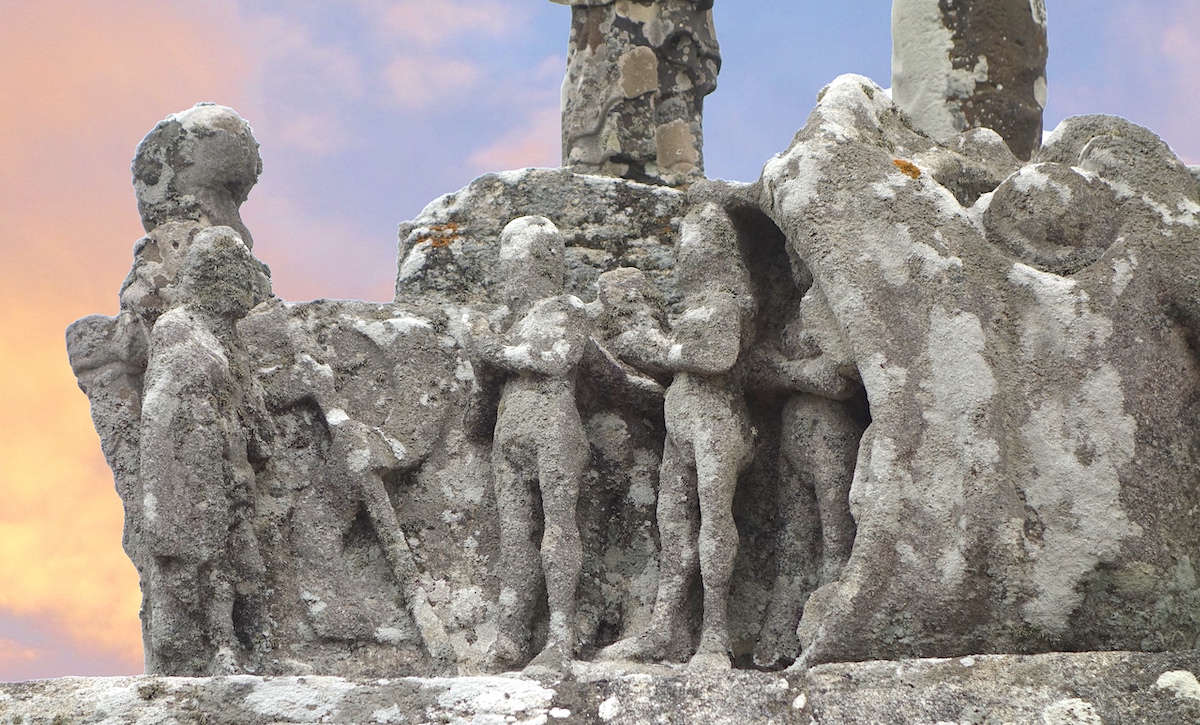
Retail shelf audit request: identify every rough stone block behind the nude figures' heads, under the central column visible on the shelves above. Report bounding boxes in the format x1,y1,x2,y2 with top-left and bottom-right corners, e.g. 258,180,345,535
396,169,685,305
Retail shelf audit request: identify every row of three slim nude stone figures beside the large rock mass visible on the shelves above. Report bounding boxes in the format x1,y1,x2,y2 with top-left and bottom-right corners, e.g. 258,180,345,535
444,192,862,672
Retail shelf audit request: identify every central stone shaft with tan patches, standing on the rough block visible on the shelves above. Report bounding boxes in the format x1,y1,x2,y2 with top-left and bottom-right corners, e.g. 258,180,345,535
551,0,721,186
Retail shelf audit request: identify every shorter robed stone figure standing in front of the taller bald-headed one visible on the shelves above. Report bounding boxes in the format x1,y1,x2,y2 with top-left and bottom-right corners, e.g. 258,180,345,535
139,227,270,675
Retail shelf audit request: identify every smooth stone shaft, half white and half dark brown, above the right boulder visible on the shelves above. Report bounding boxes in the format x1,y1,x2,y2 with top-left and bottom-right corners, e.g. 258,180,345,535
892,0,1048,160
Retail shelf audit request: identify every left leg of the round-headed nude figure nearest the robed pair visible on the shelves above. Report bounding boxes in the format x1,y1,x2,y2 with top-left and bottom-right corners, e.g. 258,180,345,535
492,437,540,667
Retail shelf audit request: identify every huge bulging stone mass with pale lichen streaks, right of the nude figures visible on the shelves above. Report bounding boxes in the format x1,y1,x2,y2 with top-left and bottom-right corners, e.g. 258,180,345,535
762,77,1200,664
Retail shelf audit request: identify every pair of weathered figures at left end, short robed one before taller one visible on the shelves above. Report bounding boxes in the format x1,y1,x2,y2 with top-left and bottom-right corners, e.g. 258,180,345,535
67,103,271,675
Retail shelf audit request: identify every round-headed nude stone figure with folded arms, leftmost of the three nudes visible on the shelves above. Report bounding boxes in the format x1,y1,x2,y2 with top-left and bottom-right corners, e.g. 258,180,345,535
467,217,588,673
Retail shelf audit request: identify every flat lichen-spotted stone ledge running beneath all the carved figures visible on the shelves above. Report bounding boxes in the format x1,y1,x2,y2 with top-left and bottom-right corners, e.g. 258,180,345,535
0,651,1200,725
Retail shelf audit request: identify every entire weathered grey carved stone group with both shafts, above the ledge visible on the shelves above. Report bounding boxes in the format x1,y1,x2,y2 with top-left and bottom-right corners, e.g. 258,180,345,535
67,0,1200,677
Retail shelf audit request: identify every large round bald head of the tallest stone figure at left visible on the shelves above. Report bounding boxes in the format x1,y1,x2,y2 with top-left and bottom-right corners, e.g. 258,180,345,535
132,103,263,247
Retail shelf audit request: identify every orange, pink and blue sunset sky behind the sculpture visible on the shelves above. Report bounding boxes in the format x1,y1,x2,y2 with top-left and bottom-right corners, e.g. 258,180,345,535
0,0,1200,681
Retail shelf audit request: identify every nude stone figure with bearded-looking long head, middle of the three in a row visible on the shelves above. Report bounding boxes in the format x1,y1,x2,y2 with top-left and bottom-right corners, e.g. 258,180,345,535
601,202,754,669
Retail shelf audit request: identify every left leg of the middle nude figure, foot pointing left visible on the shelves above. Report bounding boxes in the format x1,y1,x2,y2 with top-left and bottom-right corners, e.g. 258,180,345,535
599,433,700,660
